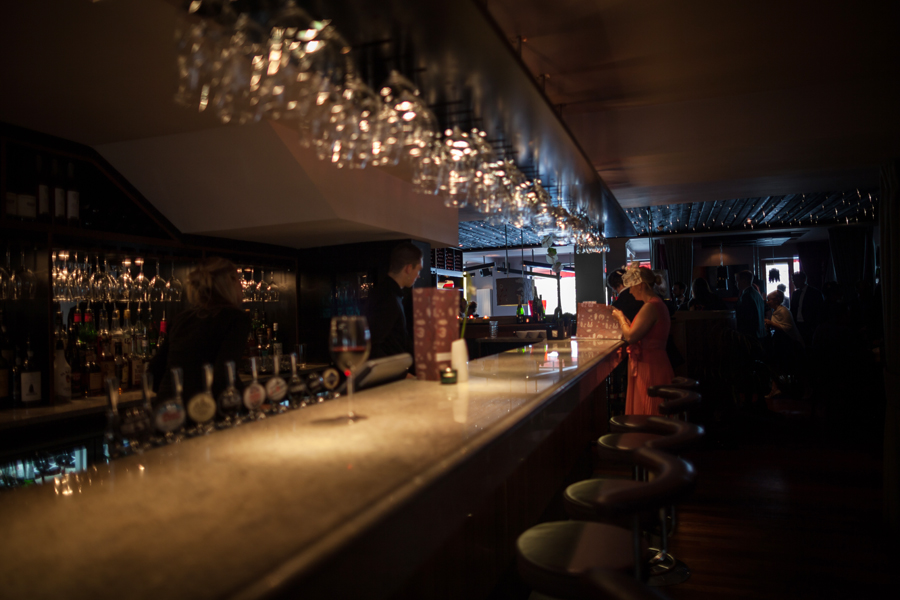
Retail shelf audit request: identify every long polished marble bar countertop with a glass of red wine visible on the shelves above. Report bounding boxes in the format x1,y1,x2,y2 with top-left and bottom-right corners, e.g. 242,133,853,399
0,340,623,599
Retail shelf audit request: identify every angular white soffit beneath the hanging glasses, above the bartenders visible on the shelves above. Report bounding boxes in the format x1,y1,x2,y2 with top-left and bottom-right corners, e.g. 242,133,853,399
97,122,458,248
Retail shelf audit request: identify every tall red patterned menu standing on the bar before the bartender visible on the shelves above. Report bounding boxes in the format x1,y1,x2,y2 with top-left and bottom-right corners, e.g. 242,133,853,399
413,288,459,381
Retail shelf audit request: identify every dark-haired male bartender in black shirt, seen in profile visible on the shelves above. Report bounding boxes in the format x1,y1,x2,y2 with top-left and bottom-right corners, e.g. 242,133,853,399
368,242,422,366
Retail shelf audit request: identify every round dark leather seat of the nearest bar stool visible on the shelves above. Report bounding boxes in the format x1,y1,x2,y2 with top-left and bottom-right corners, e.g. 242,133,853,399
516,521,647,598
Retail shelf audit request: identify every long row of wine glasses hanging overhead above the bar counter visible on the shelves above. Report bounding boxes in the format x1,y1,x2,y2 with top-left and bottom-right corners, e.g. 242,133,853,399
176,0,608,252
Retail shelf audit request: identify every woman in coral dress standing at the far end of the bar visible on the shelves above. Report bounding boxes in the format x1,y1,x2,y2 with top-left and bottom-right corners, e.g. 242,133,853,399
613,263,675,415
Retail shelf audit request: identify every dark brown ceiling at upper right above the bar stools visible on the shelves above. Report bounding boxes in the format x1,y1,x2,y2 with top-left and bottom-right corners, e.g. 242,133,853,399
486,0,900,208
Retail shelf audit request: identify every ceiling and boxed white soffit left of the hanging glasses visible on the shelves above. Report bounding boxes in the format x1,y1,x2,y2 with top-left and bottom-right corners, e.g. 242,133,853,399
0,0,458,248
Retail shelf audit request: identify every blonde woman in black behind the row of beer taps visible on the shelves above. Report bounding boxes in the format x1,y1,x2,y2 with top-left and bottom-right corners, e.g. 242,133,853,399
149,257,250,400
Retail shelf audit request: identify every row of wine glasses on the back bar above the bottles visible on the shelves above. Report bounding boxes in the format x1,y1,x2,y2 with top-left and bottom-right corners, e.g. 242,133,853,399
47,250,281,302
